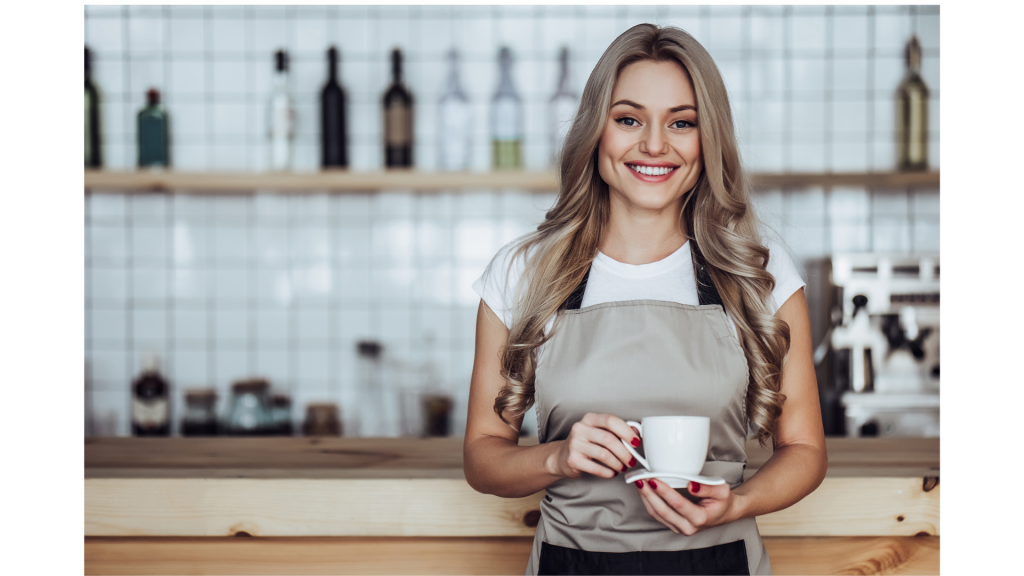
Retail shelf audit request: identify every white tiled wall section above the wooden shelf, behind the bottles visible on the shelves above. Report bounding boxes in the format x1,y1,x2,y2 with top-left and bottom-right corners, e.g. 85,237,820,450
82,4,942,171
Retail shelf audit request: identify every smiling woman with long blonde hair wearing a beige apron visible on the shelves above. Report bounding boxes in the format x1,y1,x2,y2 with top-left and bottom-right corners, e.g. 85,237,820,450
464,25,826,576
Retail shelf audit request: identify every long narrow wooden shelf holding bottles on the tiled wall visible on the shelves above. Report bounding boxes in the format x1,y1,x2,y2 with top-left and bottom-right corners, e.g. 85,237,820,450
82,170,942,195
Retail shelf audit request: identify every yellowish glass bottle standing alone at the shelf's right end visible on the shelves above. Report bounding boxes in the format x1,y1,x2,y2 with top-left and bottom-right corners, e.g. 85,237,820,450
896,36,928,170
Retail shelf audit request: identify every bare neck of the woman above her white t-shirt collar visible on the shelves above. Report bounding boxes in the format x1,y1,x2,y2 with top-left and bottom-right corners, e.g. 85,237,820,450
598,191,687,265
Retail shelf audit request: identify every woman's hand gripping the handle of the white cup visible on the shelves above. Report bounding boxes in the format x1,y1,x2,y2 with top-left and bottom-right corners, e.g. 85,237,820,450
546,414,640,479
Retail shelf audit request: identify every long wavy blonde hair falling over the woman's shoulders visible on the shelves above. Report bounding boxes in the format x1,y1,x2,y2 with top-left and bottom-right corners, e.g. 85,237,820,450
495,24,790,445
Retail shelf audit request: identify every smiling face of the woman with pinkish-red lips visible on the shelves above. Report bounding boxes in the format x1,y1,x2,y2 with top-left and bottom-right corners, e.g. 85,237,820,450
598,60,703,211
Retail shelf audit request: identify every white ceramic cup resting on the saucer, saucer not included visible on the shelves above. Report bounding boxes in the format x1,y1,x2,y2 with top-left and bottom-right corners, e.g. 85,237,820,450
623,416,711,476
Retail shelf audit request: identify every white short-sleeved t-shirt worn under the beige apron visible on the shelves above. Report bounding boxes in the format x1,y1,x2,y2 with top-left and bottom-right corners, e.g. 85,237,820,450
473,239,805,342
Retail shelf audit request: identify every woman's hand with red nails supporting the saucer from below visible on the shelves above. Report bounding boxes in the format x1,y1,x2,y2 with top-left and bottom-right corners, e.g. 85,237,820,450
635,479,741,536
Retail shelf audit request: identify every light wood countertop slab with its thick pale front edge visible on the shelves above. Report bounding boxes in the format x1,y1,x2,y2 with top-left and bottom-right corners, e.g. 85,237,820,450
82,438,942,537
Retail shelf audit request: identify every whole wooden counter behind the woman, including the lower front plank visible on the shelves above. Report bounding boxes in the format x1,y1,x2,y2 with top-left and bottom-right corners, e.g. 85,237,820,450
82,438,942,574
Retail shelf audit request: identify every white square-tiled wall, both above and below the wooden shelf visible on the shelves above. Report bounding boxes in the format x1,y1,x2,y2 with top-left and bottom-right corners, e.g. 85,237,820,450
83,4,941,436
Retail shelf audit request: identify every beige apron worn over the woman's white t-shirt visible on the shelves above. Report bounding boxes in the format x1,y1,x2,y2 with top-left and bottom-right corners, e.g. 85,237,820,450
525,258,771,576
